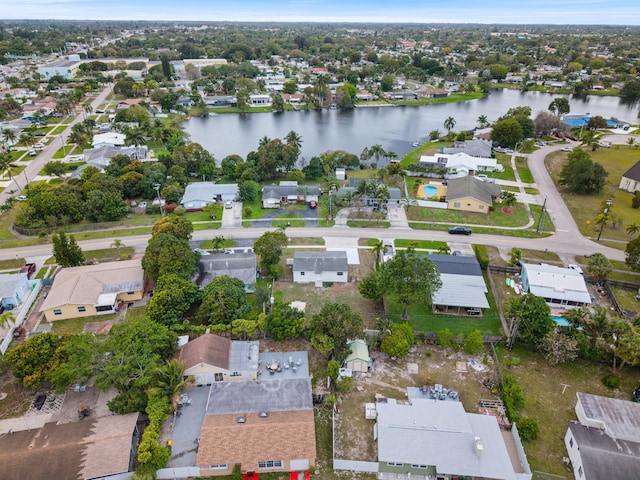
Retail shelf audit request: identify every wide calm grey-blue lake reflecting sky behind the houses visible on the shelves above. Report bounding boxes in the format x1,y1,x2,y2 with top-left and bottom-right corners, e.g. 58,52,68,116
182,90,638,163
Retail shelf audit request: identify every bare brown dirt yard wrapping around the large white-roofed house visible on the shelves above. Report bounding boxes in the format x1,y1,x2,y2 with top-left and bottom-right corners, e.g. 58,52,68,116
334,345,497,462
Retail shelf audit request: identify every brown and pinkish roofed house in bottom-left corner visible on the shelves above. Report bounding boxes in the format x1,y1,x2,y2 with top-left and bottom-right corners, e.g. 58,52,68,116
0,413,139,480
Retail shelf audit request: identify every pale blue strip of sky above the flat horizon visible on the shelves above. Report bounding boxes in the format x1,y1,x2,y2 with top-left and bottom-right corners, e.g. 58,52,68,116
0,0,640,25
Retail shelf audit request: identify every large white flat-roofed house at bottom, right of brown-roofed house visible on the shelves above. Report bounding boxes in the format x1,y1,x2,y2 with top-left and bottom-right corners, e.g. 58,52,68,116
375,388,532,480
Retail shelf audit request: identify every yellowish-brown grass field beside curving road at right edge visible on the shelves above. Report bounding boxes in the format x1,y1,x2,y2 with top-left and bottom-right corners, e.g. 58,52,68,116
545,145,640,244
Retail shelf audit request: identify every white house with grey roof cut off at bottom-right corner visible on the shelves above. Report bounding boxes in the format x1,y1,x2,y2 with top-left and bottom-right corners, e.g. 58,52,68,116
564,392,640,480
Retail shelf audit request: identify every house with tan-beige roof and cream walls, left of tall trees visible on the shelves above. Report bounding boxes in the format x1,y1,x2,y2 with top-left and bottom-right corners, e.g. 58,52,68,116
40,260,144,322
